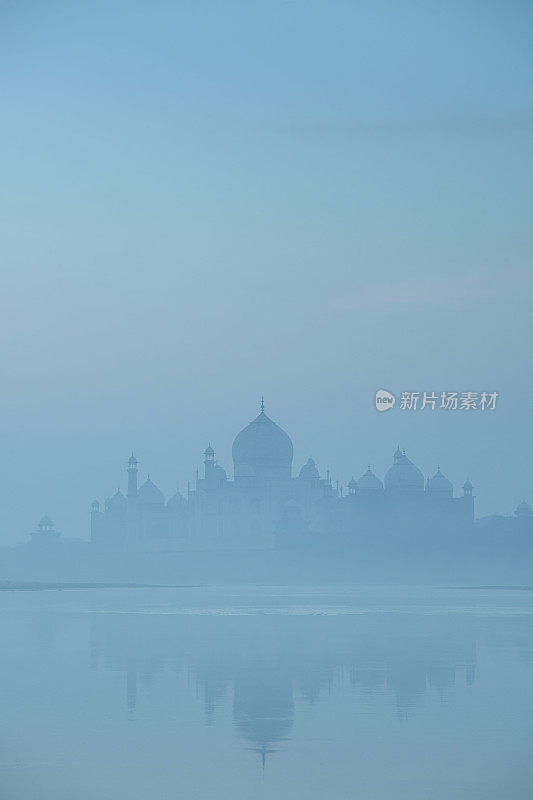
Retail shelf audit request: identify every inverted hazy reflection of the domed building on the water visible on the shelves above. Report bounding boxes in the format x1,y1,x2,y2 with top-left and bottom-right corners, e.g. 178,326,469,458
91,590,476,761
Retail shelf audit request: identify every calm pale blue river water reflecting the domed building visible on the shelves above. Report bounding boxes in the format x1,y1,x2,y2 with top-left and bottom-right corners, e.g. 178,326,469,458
0,587,533,800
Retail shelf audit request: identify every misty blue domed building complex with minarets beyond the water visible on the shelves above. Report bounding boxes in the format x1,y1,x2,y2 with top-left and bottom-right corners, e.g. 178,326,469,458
91,402,474,550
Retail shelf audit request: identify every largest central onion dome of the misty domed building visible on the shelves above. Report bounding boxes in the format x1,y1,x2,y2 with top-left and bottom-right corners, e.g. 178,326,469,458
232,411,292,485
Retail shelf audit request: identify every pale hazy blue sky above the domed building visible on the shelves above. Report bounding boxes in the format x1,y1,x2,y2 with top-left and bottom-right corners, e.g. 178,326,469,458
0,0,533,542
